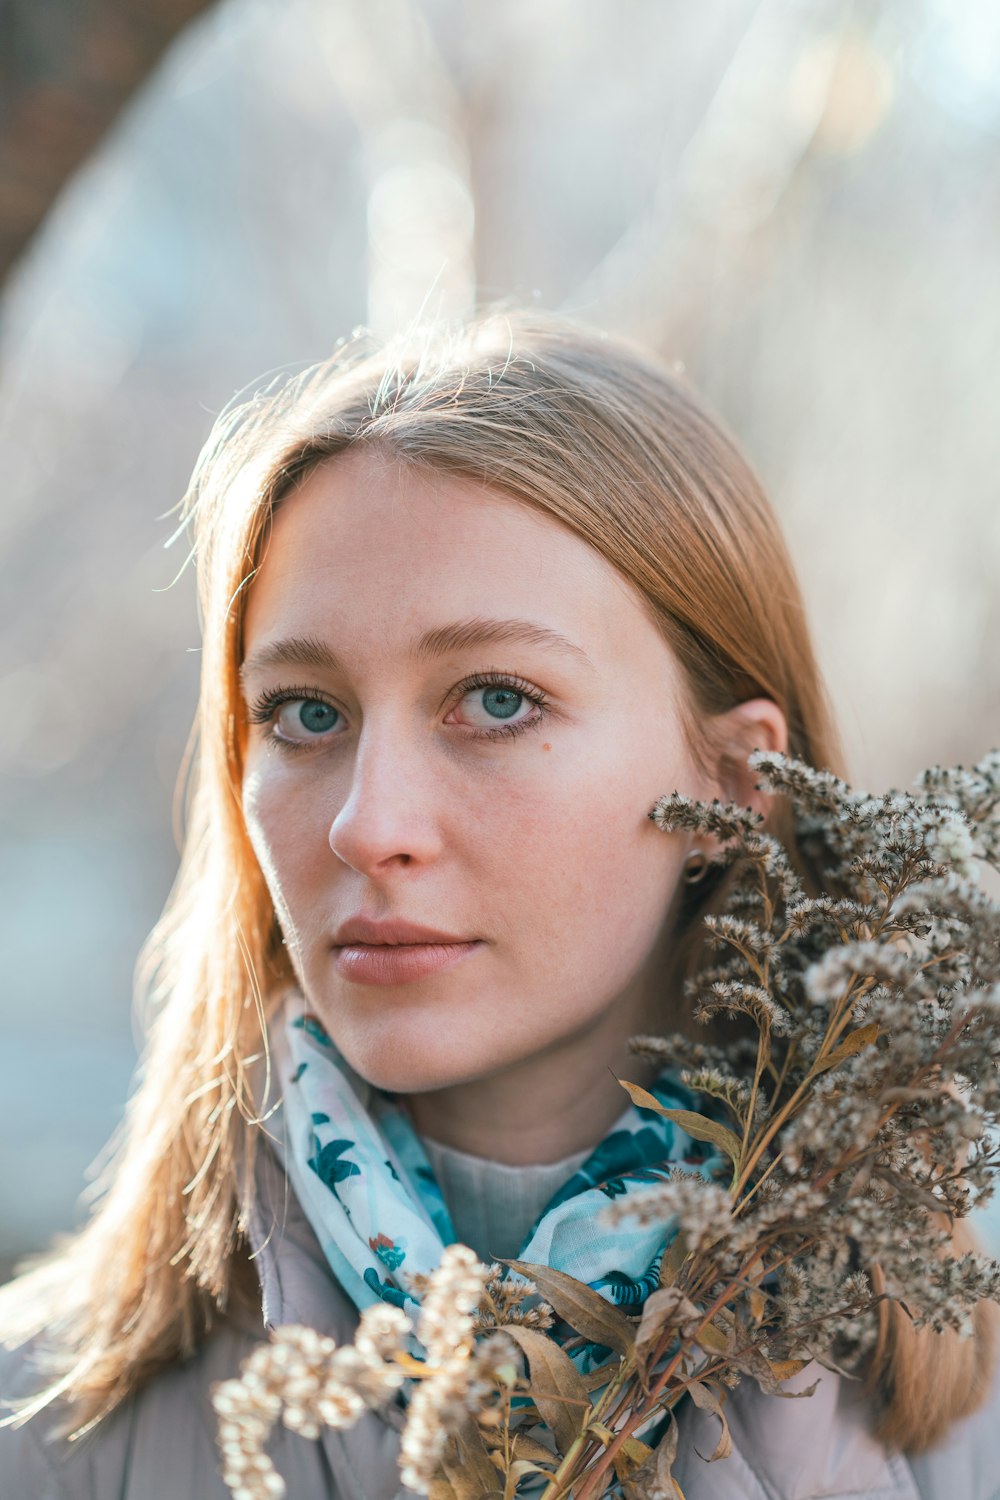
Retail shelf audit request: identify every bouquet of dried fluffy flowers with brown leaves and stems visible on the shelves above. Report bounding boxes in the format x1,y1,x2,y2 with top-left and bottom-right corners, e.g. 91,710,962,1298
214,752,1000,1500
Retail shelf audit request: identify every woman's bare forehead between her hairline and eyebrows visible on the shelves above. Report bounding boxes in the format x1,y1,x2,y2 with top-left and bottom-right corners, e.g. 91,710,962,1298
244,450,666,678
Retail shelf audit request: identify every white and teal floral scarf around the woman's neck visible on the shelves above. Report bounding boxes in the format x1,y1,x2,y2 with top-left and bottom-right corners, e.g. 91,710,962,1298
270,990,720,1332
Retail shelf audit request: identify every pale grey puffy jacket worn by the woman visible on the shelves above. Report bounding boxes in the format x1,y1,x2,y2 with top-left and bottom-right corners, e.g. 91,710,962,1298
0,1154,1000,1500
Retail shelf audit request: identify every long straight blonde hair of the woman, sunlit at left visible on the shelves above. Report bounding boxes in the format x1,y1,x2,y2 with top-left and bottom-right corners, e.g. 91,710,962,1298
0,315,993,1449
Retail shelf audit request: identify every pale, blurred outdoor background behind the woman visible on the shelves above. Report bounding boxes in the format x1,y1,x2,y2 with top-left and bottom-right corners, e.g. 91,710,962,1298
0,0,1000,1269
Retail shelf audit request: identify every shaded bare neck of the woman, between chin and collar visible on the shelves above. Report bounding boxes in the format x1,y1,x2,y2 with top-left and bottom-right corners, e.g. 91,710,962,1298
408,1019,657,1167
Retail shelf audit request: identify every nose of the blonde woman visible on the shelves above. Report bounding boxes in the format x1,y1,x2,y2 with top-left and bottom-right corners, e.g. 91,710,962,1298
328,725,441,876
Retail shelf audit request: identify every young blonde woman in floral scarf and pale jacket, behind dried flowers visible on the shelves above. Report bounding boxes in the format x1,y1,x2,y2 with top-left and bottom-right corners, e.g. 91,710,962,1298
0,315,1000,1500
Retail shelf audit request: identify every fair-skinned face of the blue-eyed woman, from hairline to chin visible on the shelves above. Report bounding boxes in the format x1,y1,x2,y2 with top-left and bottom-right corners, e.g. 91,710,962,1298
241,450,714,1098
